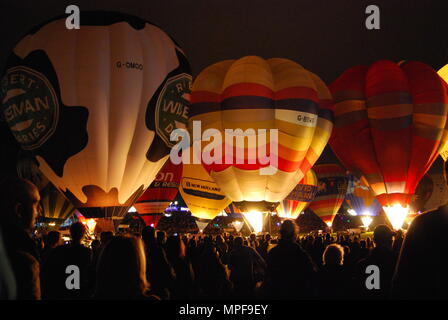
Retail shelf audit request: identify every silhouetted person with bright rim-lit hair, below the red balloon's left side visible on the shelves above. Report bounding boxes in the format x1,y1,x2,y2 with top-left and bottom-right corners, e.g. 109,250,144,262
318,243,350,299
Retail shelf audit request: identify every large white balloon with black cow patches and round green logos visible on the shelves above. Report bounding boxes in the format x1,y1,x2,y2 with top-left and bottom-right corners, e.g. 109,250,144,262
0,12,191,218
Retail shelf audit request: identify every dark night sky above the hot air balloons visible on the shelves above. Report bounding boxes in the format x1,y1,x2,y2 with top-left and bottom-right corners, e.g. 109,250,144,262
0,0,448,165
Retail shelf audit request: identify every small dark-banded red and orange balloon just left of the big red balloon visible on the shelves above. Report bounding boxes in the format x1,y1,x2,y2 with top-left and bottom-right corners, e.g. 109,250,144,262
310,164,348,228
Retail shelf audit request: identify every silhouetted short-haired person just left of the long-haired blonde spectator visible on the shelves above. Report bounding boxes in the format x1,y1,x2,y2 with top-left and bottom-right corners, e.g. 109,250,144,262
42,222,92,300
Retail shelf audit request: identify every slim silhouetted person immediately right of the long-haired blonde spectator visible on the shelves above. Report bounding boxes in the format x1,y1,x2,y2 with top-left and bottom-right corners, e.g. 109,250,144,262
142,226,175,300
